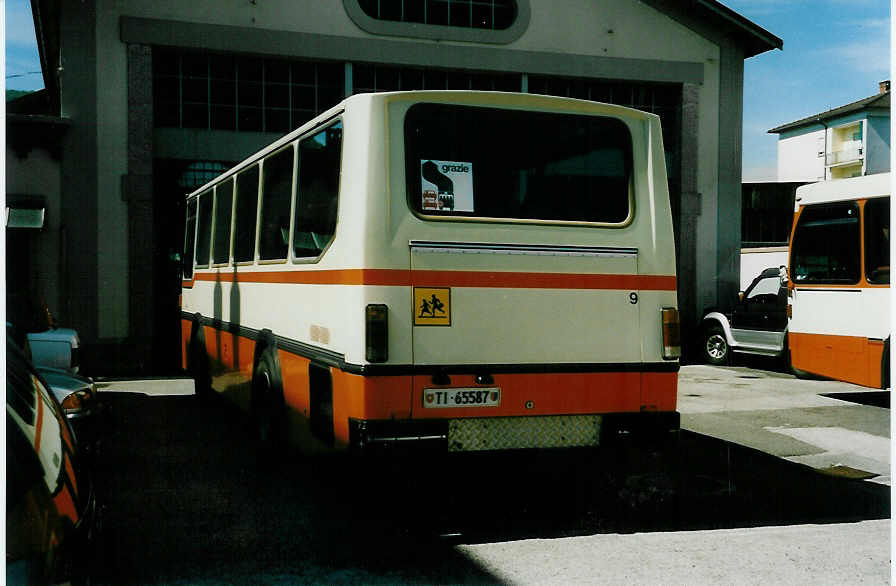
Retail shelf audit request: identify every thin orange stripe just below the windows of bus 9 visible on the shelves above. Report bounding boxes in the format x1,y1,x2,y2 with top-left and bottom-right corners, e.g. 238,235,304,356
196,269,677,291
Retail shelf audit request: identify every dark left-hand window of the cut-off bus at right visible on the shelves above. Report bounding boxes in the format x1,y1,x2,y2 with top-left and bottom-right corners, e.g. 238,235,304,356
790,202,861,284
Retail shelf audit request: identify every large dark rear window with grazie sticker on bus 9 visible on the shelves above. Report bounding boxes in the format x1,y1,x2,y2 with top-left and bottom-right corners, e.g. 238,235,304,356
404,103,632,225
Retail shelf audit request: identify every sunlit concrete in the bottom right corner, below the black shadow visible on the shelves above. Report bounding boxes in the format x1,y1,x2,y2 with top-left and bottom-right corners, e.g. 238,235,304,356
457,520,890,586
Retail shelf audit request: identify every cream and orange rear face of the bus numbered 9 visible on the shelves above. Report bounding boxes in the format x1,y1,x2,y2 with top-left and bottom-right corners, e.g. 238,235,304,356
340,92,678,451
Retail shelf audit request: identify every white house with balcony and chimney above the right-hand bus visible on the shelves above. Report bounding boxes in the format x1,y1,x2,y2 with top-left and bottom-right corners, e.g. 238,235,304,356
769,80,890,182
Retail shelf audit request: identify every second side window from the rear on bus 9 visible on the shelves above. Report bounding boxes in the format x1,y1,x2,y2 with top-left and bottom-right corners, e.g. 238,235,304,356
258,145,295,260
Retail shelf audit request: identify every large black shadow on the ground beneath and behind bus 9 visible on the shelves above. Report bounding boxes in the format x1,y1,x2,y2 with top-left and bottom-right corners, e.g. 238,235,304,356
92,393,890,584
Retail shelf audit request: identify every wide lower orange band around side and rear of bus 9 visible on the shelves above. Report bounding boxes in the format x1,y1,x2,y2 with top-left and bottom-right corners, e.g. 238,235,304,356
191,326,678,448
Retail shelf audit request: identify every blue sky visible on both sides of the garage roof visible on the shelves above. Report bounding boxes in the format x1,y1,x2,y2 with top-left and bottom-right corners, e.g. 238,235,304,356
0,0,890,181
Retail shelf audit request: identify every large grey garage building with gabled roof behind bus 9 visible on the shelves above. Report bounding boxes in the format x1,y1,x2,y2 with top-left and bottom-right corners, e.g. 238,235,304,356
7,0,782,374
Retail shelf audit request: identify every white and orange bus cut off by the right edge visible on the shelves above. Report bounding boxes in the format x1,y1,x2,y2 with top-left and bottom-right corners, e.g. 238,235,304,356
788,173,890,388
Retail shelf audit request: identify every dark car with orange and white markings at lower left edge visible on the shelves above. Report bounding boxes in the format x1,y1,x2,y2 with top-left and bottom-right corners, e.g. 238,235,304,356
6,335,95,584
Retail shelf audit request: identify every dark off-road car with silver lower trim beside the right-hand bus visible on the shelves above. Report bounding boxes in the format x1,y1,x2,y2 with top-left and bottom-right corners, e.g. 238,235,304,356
700,267,787,365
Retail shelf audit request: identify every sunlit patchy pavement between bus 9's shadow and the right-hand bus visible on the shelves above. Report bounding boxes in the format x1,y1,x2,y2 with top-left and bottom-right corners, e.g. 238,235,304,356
678,365,890,485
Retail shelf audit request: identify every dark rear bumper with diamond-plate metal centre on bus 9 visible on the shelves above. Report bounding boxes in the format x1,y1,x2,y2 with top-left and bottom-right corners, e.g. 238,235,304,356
349,411,681,453
